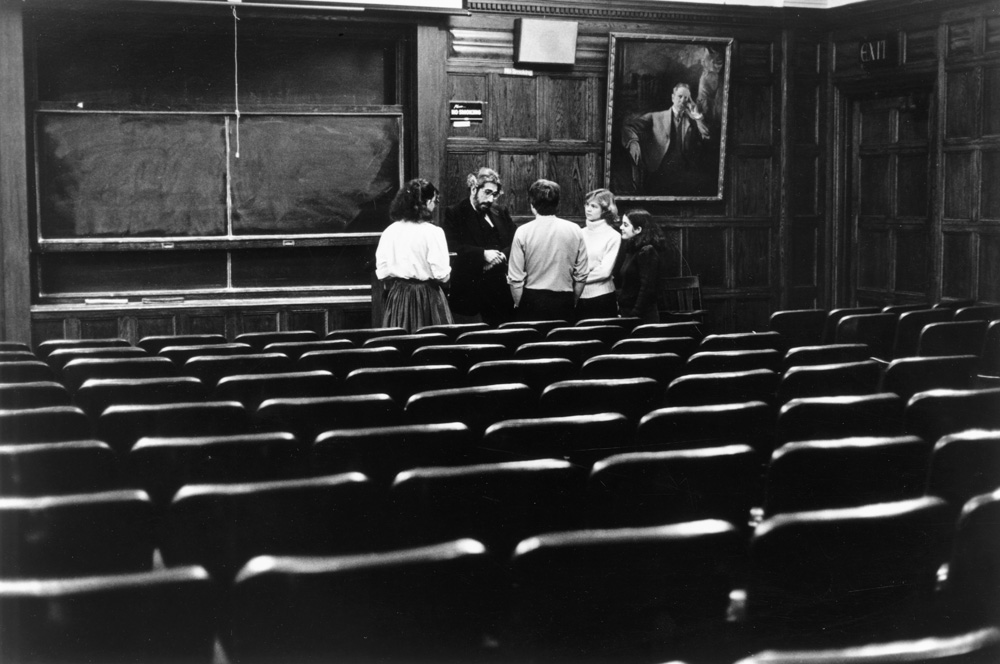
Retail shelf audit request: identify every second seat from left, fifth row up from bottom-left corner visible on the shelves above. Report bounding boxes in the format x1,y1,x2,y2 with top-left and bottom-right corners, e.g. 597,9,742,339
73,376,209,419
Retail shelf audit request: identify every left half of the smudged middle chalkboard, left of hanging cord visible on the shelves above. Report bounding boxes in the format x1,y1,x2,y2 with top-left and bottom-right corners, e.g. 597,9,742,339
37,113,226,238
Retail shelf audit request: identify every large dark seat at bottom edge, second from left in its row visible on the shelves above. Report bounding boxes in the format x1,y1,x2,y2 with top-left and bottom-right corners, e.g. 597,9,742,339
221,539,501,664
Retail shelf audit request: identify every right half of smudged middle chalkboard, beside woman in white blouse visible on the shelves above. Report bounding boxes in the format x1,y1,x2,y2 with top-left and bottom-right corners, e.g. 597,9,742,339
230,115,400,235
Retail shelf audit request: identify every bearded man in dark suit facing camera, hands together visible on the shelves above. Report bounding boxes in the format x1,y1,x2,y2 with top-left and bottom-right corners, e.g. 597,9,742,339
444,167,516,326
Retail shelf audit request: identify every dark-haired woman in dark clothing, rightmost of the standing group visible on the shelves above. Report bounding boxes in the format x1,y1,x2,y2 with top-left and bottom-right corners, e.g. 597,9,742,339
617,210,667,323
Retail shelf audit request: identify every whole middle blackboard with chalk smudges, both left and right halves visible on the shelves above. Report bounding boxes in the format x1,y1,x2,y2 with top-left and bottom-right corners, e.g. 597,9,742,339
37,113,401,239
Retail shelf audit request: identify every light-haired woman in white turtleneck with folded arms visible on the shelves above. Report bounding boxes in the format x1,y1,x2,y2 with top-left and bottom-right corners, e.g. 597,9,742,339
576,189,622,320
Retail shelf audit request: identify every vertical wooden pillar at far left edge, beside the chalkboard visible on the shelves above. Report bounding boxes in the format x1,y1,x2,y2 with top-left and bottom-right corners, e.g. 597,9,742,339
0,2,32,342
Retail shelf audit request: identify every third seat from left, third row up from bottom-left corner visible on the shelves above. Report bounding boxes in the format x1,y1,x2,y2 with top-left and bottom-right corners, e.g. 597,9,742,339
309,421,479,487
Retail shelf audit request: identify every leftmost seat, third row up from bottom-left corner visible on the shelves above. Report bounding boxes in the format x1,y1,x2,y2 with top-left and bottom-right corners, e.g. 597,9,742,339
0,440,119,496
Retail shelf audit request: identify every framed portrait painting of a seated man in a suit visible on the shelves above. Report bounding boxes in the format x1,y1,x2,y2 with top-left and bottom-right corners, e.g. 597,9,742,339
604,32,733,201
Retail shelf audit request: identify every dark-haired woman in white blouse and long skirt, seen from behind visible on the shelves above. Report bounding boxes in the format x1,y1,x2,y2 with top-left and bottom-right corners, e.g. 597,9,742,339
375,178,454,332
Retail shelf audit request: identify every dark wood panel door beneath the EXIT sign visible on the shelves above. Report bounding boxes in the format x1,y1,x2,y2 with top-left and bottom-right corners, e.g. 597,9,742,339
841,91,935,305
